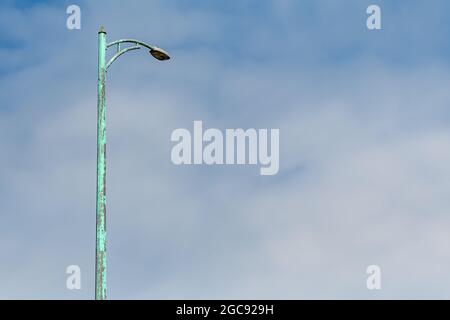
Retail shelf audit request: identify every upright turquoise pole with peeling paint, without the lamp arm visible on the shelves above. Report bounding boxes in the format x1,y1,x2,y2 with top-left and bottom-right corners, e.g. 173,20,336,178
95,27,106,300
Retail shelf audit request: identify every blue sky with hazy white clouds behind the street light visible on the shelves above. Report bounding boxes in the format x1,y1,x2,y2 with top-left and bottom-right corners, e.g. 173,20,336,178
0,0,450,299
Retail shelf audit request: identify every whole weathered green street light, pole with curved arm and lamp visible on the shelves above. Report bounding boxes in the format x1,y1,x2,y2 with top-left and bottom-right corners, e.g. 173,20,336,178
95,27,170,300
